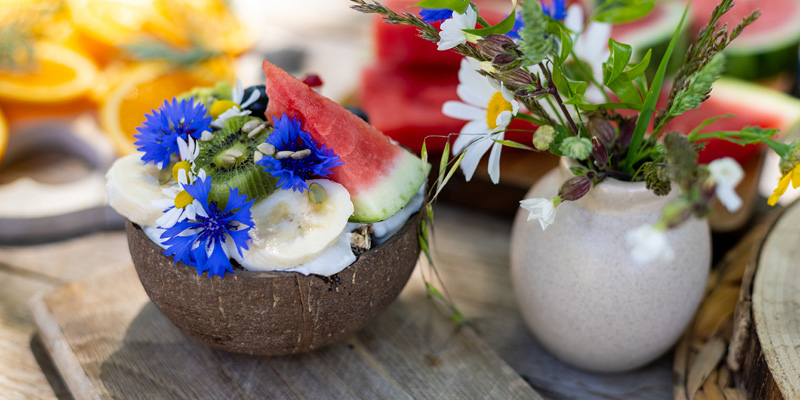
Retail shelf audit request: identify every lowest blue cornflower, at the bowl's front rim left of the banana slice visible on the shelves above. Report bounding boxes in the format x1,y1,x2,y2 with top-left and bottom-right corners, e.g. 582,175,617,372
161,176,253,278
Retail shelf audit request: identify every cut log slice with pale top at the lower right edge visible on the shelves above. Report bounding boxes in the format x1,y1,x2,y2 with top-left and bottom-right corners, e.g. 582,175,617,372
745,198,800,399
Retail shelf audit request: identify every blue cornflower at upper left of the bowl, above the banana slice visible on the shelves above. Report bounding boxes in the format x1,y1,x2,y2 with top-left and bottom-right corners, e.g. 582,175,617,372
133,98,211,168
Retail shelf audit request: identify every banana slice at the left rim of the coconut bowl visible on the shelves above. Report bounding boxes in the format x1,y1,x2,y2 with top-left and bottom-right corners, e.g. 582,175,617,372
106,153,167,226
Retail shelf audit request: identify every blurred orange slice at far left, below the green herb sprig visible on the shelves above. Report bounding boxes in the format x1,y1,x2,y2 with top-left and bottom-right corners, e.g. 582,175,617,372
0,42,97,103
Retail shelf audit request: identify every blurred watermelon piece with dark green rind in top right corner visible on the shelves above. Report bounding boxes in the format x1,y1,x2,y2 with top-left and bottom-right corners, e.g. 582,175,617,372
692,0,800,79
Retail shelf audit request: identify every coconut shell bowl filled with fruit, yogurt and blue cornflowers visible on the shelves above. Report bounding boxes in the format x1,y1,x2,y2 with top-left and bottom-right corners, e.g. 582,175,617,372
107,62,432,355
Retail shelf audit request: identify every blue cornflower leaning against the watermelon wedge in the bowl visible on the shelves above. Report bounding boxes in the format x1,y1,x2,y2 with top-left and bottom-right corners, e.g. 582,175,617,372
258,114,344,192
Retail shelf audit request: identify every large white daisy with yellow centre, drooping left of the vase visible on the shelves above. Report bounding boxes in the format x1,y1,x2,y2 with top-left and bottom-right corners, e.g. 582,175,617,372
442,58,519,183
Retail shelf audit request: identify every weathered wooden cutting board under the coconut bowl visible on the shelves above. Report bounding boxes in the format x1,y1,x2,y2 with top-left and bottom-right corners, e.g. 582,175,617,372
31,266,541,399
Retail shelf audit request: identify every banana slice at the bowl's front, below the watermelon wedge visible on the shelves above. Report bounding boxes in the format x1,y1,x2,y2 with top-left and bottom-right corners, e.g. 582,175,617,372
232,179,353,271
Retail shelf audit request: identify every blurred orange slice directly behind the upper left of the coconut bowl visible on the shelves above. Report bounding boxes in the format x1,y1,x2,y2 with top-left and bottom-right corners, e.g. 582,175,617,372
100,64,230,155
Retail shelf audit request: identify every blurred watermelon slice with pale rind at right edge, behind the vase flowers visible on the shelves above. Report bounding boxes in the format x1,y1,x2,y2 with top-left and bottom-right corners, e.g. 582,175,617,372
667,78,800,164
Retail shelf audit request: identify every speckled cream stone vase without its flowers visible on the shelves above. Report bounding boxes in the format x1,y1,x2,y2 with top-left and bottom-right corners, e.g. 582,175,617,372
511,159,711,372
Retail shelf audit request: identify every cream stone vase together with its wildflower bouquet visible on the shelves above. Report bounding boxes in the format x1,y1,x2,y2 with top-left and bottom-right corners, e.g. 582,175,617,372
353,0,800,371
